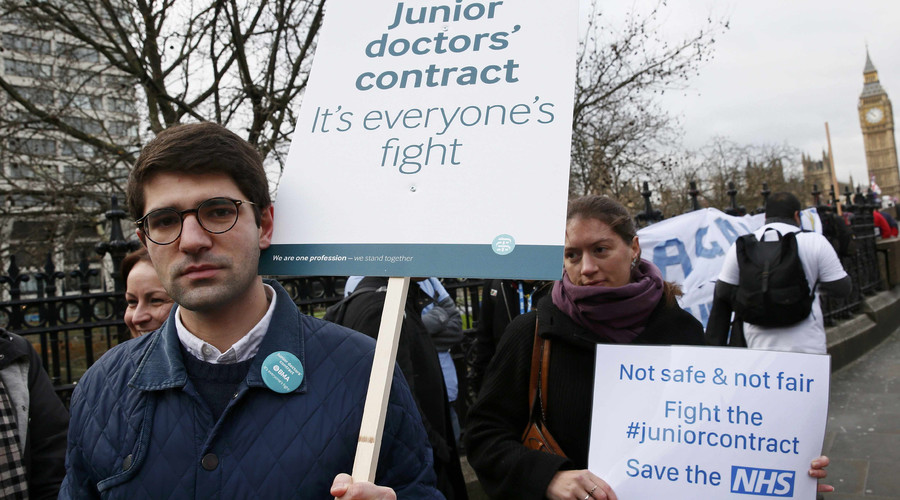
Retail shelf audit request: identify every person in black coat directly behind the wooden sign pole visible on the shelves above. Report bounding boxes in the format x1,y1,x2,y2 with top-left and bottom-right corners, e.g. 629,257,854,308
339,276,468,500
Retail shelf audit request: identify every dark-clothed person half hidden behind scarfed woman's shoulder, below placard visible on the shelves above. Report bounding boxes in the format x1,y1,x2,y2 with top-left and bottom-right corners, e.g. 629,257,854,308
466,280,549,401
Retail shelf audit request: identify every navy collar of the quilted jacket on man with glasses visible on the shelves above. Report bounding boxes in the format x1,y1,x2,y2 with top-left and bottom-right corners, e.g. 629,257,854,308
128,280,307,393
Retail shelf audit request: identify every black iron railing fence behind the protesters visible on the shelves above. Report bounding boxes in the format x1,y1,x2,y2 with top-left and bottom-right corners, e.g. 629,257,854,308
0,183,883,406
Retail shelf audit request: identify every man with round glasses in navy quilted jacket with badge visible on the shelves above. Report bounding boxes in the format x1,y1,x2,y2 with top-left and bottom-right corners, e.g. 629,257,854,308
61,123,442,499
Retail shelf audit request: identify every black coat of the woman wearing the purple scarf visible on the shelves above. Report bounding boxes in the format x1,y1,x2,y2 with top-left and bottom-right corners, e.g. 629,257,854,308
466,297,704,499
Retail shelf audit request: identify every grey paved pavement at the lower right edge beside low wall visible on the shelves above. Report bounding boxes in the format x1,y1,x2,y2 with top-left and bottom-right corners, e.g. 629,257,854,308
824,328,900,500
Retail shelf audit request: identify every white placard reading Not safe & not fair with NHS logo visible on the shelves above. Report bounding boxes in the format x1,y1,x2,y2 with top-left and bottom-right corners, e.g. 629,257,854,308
588,344,831,500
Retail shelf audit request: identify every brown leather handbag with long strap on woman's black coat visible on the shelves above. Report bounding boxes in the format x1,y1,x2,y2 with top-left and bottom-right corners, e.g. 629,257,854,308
522,319,566,457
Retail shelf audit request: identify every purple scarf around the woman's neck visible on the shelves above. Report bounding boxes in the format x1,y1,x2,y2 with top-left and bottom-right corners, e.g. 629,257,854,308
551,259,663,344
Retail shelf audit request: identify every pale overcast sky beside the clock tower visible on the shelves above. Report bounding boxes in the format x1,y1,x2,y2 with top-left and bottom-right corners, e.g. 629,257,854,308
581,0,900,188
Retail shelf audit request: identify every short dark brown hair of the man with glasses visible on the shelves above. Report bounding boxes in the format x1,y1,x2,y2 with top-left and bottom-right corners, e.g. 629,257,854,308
126,122,272,225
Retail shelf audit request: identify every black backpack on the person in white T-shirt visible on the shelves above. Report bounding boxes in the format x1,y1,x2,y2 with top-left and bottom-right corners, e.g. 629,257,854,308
732,228,815,327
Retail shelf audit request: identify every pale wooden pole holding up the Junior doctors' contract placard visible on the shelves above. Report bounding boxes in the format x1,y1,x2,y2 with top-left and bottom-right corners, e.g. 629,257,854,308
352,278,409,482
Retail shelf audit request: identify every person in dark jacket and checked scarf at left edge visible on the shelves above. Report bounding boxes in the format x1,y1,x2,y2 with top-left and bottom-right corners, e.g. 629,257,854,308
0,328,69,500
